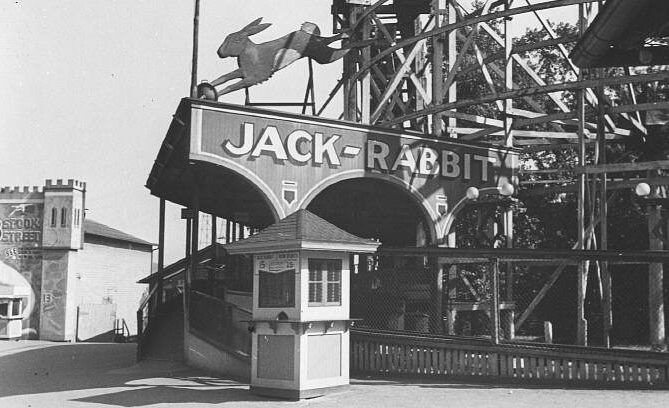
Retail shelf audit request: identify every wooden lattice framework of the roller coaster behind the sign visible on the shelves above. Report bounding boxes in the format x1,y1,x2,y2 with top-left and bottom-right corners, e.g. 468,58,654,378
321,0,669,344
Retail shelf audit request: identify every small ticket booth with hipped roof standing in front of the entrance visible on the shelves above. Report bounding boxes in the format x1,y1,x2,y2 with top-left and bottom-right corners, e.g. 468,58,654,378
226,210,379,399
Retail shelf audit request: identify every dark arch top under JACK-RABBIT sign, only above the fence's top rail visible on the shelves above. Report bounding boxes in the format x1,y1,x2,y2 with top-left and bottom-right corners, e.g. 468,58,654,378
307,178,432,246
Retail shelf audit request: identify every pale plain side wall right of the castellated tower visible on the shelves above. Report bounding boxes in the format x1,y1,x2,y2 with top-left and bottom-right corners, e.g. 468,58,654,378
70,237,151,335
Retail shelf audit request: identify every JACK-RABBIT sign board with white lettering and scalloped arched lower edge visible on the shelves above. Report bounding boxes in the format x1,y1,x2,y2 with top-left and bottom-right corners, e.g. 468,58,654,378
189,103,518,242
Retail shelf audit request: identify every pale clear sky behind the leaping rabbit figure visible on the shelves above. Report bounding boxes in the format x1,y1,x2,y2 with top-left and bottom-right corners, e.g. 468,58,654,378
0,0,576,262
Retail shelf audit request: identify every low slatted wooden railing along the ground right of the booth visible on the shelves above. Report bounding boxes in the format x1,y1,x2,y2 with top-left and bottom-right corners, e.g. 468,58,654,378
350,328,669,388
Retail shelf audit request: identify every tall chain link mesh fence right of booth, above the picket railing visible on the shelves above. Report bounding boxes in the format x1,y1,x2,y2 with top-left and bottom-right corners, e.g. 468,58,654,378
351,255,669,349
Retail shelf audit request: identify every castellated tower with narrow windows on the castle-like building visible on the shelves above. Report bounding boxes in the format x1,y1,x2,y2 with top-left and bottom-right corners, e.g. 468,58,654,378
39,179,86,341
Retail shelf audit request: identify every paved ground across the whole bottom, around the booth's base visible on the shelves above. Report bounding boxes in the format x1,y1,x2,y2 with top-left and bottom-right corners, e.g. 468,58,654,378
0,341,669,408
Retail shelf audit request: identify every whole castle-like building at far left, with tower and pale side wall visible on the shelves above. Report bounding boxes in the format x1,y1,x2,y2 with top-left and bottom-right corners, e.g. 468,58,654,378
0,179,153,341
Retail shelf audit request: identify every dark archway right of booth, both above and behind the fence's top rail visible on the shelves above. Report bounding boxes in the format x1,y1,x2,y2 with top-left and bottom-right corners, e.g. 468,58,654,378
307,178,436,330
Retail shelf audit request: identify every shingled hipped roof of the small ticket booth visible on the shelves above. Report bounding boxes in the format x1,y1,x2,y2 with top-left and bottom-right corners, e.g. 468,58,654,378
224,209,380,253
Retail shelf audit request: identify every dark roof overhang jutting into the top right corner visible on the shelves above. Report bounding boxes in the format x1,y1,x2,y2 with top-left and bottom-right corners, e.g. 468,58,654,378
570,0,669,68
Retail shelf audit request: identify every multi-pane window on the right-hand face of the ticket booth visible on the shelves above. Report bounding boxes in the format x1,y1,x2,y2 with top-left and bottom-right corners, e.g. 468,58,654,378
309,259,341,306
